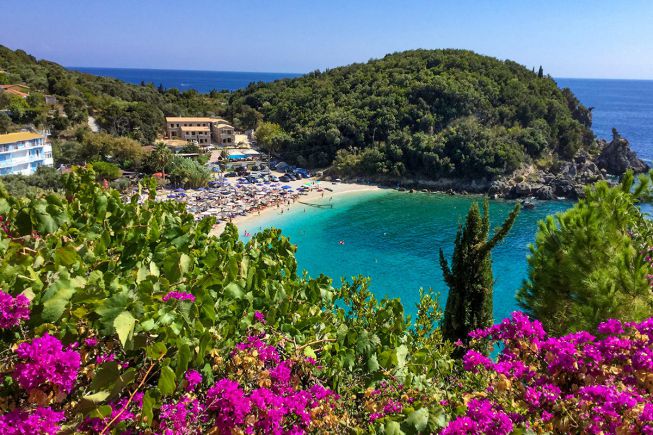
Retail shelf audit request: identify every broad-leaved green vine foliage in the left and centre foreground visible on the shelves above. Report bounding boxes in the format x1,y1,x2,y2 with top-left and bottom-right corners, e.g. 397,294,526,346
0,169,453,428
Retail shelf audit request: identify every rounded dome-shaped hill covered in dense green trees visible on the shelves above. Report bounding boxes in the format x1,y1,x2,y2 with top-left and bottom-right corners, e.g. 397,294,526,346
228,50,594,179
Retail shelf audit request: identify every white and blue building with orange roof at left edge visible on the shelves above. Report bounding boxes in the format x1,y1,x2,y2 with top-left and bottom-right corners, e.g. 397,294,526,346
0,132,54,175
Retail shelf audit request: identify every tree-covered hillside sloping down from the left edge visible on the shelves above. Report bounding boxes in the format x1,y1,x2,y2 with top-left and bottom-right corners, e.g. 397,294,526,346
0,45,226,144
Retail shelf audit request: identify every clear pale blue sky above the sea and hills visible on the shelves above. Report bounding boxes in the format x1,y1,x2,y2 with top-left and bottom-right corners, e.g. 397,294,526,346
0,0,653,79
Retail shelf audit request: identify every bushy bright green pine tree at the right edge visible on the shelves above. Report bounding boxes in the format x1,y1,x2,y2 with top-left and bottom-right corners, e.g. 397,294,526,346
517,174,653,334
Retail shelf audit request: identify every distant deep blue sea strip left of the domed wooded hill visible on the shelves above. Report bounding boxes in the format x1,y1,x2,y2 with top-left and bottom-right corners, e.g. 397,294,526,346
68,67,302,93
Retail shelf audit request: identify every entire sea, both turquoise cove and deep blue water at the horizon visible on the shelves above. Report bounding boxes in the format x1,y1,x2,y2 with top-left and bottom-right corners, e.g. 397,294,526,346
73,68,653,320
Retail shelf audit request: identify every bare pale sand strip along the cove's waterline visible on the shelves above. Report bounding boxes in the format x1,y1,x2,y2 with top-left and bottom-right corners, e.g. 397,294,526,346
211,178,381,235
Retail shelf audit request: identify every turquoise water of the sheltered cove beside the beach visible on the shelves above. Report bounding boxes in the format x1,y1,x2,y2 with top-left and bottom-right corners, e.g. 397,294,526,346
239,191,571,319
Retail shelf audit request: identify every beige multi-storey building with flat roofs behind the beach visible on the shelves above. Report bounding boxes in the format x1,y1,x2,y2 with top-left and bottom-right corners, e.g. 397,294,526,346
166,116,234,146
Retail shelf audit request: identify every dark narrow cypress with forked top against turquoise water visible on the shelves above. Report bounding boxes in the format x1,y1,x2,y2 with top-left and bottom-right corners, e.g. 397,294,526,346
440,199,519,348
